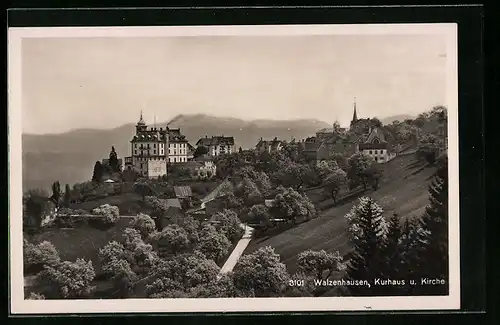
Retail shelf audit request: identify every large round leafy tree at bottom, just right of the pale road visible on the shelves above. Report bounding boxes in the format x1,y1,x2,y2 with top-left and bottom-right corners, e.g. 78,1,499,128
232,246,289,297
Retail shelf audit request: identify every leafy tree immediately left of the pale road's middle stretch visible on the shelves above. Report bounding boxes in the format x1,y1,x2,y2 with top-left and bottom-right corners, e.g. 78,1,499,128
198,224,231,262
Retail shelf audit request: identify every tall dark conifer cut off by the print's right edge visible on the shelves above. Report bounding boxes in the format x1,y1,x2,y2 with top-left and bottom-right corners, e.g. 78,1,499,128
419,156,449,295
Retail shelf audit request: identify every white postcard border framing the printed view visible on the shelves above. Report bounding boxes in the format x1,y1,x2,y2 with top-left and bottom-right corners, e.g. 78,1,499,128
8,23,460,314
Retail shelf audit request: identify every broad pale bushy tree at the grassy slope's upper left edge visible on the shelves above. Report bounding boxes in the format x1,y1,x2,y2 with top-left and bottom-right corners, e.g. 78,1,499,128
271,188,316,224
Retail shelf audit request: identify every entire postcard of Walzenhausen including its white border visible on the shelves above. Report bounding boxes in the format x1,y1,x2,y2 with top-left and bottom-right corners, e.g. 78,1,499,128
8,24,460,313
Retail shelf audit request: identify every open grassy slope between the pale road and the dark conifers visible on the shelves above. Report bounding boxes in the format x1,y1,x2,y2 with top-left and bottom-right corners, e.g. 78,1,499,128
245,155,434,272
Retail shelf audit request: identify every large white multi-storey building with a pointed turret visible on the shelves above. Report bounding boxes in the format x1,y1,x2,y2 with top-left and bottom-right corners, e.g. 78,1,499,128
125,112,189,177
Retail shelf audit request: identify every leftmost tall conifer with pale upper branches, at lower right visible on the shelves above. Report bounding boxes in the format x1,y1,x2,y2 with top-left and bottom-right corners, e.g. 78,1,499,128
345,197,388,295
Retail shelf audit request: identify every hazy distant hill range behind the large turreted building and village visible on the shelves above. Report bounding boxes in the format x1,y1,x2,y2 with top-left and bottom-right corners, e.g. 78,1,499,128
22,114,330,189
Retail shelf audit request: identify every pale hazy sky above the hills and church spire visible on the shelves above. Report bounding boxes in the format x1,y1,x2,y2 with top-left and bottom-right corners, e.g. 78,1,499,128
21,35,446,134
